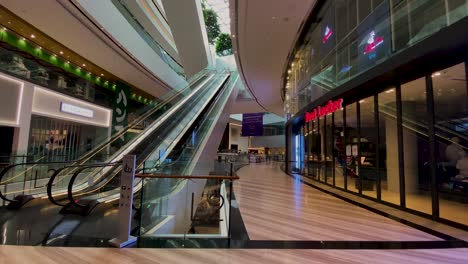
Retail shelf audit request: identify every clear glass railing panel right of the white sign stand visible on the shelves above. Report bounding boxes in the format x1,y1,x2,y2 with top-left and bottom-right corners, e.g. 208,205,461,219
139,163,231,247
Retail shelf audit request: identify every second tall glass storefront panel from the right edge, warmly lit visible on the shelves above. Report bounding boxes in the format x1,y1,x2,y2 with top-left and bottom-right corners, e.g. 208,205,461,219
401,77,432,214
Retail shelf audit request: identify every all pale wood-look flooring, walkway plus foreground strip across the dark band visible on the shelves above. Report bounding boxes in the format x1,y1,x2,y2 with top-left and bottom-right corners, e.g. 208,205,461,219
0,164,468,264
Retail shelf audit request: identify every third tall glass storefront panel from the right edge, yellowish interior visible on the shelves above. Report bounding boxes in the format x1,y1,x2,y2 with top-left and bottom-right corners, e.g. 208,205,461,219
378,88,400,205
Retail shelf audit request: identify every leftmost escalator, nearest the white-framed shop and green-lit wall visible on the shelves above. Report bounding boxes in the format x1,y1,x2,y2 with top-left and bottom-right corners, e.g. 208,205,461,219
0,67,215,209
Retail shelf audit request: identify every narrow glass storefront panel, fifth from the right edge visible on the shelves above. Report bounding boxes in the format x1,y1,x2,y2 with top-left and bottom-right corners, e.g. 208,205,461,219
345,103,359,192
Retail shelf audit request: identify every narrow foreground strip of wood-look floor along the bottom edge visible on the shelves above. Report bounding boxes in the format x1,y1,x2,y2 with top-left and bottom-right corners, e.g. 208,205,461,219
0,246,468,264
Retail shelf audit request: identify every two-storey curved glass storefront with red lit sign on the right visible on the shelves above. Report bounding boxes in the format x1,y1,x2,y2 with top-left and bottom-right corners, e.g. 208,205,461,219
285,0,468,228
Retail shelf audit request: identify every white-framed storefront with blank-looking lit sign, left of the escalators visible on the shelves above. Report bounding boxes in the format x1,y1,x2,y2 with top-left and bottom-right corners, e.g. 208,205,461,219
0,73,112,162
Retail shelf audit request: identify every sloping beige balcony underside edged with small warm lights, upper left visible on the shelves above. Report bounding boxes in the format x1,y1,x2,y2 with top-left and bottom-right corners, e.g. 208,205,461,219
0,0,171,97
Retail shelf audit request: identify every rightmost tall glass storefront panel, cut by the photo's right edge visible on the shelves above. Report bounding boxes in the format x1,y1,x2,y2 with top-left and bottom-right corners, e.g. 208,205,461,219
432,63,468,225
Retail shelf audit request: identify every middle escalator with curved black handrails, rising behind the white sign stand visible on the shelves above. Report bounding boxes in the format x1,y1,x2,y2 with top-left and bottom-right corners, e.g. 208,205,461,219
48,73,229,215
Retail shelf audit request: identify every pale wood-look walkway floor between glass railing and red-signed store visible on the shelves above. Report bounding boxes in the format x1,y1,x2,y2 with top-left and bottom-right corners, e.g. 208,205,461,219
234,163,440,241
